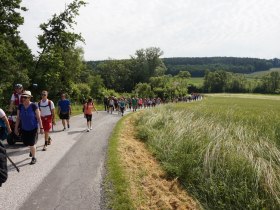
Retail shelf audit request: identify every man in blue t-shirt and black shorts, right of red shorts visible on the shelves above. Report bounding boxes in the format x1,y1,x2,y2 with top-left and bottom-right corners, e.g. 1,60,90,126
58,93,71,130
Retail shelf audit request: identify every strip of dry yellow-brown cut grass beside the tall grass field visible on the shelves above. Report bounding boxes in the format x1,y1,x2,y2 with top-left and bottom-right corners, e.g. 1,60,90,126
118,115,200,209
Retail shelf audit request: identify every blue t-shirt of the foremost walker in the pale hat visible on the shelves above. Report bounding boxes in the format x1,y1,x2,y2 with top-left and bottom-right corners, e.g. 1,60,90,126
18,103,38,131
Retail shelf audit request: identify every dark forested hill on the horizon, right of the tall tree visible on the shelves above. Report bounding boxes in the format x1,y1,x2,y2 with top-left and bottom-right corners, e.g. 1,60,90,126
162,57,280,77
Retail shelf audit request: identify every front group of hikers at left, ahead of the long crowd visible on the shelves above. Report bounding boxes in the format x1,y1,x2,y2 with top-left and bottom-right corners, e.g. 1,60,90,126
0,84,101,186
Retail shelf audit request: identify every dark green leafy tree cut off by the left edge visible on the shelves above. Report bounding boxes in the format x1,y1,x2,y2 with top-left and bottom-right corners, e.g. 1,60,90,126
0,0,33,107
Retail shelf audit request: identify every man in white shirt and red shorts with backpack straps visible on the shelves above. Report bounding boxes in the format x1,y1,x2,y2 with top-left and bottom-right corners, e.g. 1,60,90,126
38,90,55,151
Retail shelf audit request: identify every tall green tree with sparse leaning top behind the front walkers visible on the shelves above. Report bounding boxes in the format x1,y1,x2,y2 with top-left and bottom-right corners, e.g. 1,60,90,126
33,0,86,99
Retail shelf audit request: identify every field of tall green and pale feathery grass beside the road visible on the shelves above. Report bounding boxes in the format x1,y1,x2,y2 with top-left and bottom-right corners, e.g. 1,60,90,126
137,97,280,209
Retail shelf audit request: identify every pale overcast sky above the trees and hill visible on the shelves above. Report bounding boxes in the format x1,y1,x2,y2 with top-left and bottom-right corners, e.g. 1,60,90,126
19,0,280,61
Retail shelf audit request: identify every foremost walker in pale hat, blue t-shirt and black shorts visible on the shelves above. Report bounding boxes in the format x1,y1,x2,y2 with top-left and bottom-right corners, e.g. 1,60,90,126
15,90,44,165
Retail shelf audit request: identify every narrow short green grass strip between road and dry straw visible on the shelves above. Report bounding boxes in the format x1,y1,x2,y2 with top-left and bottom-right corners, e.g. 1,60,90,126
105,116,135,210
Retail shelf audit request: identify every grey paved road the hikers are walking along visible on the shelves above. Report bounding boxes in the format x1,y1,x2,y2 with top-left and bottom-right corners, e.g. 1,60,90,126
0,112,120,210
